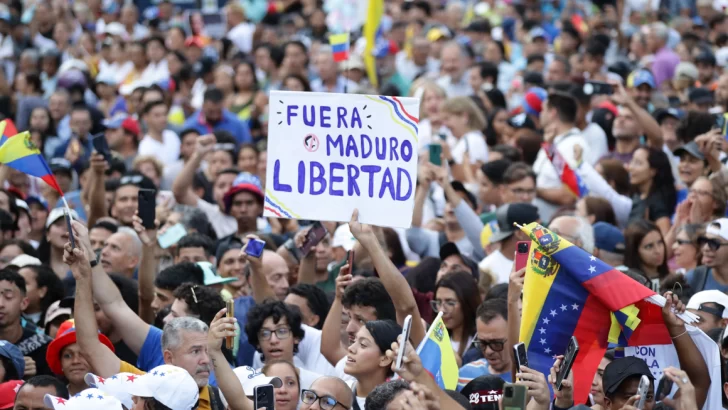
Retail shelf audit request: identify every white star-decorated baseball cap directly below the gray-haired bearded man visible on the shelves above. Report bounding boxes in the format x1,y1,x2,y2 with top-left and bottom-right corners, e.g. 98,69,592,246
119,364,200,410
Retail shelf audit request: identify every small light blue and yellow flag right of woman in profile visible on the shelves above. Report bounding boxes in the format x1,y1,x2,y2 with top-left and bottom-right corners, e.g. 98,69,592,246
417,312,459,390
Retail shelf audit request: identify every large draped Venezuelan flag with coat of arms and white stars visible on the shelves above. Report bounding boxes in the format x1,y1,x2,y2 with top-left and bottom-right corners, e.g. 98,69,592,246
520,222,671,403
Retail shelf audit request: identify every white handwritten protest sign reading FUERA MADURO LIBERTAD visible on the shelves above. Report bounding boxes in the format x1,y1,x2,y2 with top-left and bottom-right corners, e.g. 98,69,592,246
264,91,419,228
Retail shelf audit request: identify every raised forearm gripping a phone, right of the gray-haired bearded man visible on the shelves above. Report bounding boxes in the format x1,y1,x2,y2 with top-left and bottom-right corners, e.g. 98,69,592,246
207,309,253,410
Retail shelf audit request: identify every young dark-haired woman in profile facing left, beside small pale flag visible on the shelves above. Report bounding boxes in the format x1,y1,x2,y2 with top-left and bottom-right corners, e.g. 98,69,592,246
344,320,402,410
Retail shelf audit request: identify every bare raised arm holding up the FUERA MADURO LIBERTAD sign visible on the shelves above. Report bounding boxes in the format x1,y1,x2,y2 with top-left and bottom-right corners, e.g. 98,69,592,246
349,209,425,345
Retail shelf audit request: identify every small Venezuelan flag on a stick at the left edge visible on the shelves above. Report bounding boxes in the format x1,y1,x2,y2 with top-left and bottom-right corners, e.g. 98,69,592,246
0,131,63,196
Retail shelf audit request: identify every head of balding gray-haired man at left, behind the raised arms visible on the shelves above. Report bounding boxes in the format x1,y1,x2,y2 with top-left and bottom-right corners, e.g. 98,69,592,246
99,226,142,279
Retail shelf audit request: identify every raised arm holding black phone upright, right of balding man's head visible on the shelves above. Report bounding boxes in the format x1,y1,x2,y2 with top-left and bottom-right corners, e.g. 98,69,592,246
132,211,159,324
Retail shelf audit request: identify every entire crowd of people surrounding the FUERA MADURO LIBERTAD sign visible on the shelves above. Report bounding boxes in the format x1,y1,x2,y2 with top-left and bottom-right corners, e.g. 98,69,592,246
0,0,728,410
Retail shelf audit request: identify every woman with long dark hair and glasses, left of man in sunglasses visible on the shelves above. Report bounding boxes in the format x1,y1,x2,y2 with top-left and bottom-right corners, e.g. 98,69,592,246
430,272,481,364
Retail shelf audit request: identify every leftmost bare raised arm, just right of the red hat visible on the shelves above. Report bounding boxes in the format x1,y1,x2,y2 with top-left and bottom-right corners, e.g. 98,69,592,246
68,239,121,377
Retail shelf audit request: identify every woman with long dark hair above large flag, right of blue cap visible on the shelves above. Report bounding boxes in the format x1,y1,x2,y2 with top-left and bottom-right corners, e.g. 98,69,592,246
624,220,670,289
